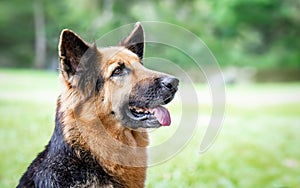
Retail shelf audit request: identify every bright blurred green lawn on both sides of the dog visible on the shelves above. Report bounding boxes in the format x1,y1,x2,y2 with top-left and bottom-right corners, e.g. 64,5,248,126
0,69,300,188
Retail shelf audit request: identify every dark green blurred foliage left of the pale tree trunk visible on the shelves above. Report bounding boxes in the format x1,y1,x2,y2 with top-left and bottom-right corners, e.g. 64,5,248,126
0,0,34,67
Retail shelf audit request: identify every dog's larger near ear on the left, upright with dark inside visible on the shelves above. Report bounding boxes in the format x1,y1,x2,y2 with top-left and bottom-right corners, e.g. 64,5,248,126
58,29,90,80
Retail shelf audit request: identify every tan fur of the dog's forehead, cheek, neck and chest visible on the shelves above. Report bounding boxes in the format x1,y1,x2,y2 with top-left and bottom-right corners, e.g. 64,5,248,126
60,47,156,187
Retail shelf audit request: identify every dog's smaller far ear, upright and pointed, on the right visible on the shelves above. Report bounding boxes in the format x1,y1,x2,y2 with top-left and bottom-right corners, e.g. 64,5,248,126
119,22,145,60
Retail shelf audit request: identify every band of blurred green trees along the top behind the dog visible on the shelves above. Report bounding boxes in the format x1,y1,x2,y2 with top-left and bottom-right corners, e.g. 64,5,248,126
0,0,300,69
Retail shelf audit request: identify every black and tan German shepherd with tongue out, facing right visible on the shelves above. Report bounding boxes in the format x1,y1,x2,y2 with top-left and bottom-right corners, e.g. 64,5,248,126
17,22,179,187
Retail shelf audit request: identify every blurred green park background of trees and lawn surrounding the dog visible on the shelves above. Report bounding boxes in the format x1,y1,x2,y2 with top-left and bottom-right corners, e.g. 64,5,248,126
0,0,300,188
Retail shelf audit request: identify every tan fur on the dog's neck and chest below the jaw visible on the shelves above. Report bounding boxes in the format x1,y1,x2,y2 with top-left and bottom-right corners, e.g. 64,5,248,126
60,84,148,187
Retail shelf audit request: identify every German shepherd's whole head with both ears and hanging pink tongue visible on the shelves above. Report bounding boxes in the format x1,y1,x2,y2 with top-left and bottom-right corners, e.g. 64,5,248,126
59,24,179,129
